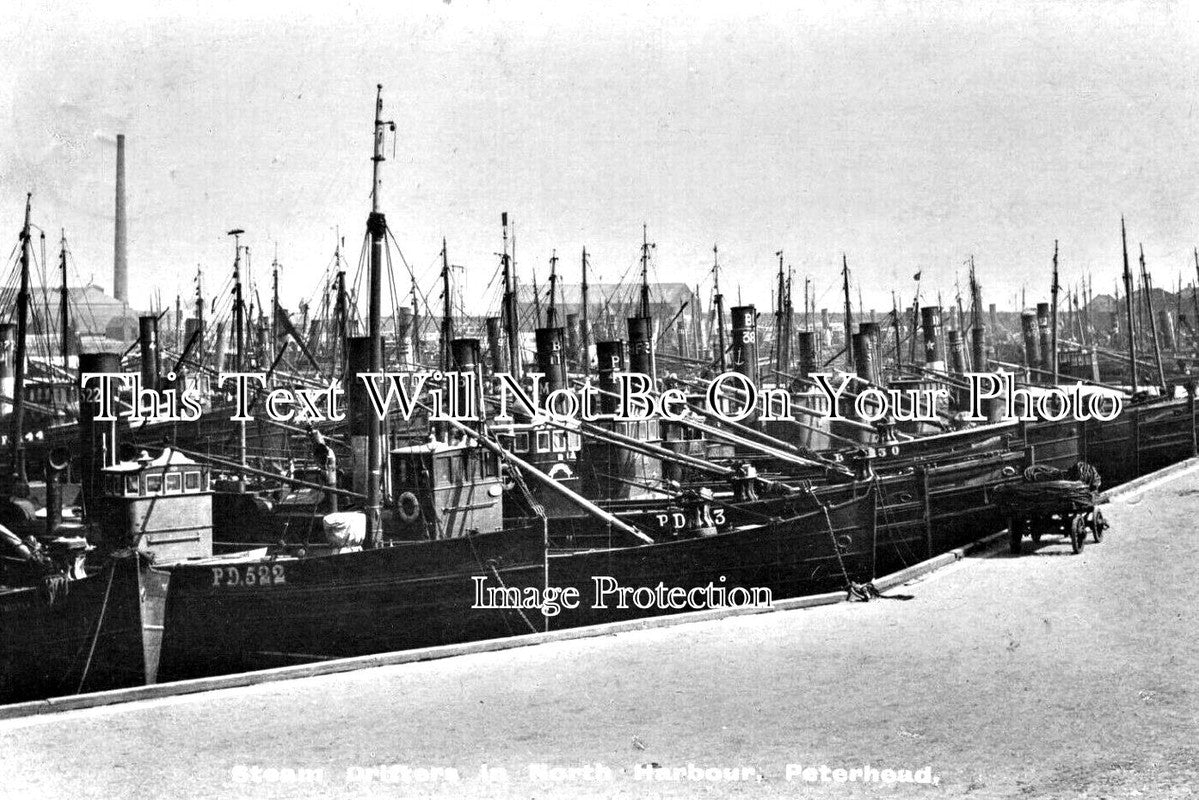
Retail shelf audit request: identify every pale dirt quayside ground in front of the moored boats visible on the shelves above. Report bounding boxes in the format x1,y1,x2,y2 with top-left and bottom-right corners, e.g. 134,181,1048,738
0,474,1199,799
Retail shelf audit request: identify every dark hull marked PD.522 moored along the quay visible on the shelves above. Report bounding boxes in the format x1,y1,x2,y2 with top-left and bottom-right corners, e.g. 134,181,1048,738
161,528,544,680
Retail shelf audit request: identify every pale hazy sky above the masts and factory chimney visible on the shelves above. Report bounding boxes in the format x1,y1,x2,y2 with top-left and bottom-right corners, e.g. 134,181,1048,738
0,0,1199,313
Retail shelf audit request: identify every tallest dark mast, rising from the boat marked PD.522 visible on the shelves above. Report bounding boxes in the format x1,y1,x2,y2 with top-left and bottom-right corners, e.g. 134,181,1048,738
366,84,396,548
